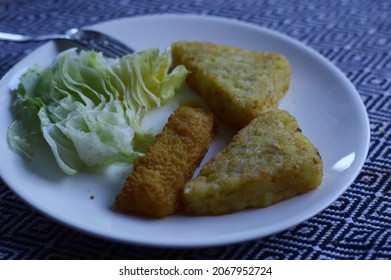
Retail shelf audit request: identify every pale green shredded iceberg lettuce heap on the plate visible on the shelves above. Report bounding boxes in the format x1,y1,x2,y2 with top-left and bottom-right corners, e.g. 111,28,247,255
8,49,188,175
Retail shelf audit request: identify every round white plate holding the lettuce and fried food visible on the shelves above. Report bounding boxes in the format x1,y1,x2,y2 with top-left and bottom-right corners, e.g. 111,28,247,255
0,15,370,247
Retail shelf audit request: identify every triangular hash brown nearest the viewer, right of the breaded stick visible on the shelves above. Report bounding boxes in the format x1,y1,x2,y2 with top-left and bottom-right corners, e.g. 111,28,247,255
183,110,323,215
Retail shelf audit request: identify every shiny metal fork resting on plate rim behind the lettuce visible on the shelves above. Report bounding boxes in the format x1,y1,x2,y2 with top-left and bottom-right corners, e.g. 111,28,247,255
0,28,134,57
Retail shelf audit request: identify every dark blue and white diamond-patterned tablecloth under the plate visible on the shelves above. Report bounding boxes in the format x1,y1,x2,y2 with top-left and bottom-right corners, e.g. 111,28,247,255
0,0,391,259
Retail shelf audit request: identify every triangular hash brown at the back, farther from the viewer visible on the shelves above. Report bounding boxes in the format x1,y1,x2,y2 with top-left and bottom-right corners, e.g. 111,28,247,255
171,41,290,130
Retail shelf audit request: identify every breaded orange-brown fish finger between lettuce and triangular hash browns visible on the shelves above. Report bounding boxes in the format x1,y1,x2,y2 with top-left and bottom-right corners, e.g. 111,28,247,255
116,107,215,218
